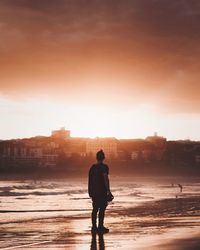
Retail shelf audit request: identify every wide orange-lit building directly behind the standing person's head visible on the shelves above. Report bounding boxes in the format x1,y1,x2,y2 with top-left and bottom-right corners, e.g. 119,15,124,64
86,137,117,158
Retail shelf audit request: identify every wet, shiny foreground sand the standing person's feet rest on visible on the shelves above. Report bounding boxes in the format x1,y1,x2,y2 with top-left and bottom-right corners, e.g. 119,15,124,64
0,197,200,250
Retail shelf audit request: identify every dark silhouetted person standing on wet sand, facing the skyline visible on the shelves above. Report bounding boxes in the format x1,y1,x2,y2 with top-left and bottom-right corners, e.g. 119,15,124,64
88,150,113,233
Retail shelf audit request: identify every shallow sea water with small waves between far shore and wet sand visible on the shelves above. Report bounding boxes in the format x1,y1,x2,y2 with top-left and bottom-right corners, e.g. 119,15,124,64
0,177,200,224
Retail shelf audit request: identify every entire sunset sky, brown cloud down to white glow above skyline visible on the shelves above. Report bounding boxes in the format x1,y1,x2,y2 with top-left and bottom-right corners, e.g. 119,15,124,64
0,0,200,140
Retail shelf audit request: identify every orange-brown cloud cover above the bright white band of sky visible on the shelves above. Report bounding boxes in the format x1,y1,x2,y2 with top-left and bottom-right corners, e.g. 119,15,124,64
0,0,200,112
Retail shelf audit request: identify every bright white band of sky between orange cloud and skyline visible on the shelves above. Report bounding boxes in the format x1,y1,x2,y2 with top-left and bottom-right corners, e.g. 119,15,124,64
0,94,200,139
